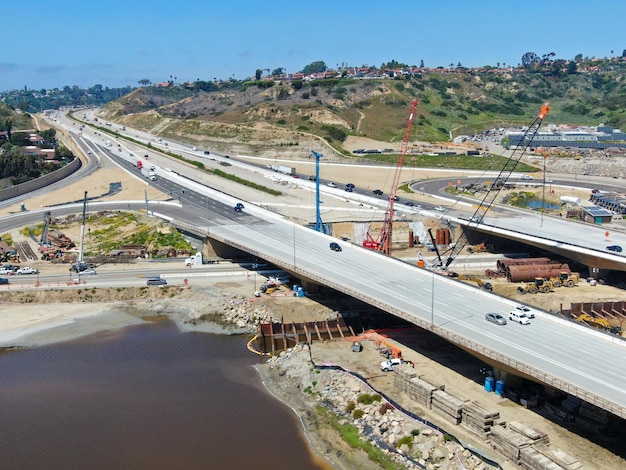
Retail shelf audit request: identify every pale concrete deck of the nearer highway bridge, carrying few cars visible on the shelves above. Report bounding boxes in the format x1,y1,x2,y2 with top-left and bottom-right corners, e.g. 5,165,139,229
7,111,626,417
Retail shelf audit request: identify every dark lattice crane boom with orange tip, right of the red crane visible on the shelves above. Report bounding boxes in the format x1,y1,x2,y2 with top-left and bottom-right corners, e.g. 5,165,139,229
445,103,550,268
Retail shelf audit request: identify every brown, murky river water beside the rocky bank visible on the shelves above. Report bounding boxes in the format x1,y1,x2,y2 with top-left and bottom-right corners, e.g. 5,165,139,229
0,321,325,470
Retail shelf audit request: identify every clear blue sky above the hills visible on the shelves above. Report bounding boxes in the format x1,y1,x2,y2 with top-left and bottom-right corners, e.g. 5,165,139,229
0,0,626,90
